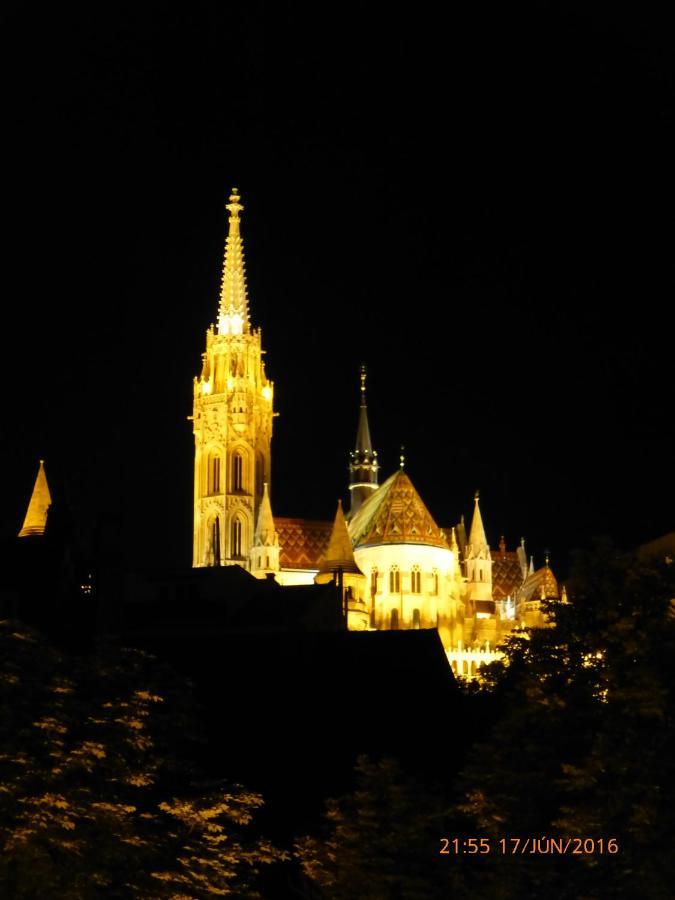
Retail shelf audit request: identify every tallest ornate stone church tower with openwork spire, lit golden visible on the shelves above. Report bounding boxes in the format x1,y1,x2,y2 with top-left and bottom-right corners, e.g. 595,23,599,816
192,188,274,567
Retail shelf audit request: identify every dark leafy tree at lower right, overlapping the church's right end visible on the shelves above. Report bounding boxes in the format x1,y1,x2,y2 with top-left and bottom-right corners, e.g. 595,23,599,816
462,545,675,898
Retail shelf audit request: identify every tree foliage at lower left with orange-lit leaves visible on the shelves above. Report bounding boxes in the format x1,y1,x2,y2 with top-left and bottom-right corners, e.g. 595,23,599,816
0,622,278,900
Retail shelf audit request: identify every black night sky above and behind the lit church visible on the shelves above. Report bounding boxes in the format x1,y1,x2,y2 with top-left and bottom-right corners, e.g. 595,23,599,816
0,2,675,567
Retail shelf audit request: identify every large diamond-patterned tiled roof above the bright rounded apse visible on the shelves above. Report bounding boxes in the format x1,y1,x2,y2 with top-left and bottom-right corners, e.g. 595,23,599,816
349,469,448,550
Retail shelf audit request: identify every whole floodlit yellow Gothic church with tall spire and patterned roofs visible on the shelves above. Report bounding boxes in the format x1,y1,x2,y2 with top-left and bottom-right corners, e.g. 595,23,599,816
191,189,558,674
